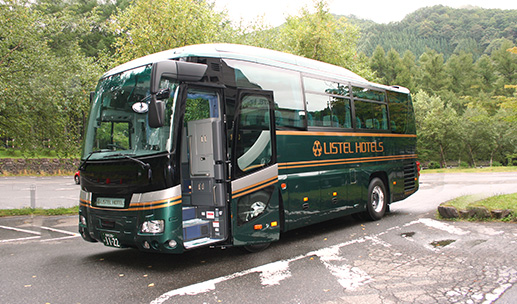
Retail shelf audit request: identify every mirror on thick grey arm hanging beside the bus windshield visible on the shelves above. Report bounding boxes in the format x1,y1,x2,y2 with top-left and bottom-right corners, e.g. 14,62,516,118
149,60,208,128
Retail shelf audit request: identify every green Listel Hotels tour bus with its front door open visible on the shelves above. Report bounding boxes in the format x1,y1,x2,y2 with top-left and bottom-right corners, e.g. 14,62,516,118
79,44,420,253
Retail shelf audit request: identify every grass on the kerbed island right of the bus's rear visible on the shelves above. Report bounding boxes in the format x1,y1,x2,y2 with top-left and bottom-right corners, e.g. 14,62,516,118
442,193,517,222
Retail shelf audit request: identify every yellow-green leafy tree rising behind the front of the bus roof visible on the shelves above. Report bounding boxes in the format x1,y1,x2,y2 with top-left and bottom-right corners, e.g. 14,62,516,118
110,0,235,64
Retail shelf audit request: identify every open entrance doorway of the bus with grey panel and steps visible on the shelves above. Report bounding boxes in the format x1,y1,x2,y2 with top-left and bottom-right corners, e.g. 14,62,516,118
180,86,229,249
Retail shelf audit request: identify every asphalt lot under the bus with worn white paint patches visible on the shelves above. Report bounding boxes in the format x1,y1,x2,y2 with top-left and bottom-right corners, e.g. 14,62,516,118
0,173,517,304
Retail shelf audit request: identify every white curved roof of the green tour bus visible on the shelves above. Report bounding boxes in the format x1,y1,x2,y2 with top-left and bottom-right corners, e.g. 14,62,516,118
103,43,409,93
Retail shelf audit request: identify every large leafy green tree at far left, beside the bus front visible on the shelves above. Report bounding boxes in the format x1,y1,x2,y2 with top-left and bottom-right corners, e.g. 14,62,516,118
0,0,100,156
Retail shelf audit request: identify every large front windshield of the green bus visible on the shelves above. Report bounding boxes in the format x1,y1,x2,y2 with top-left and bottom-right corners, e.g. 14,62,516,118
83,65,177,160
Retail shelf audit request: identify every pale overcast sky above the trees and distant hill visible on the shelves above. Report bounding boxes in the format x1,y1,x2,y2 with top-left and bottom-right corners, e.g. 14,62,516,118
213,0,517,26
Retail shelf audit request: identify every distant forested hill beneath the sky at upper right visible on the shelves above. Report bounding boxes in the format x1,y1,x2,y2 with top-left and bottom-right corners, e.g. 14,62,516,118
346,5,517,58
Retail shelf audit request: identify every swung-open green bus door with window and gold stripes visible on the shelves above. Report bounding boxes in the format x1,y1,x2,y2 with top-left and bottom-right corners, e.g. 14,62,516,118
231,90,281,248
